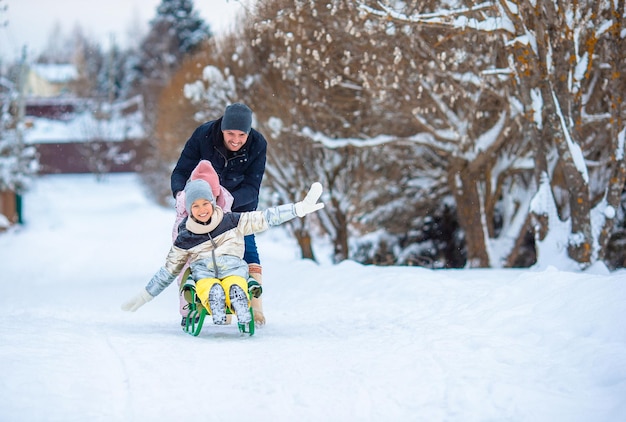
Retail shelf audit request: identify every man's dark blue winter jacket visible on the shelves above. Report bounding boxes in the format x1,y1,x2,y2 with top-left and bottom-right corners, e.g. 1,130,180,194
171,118,267,212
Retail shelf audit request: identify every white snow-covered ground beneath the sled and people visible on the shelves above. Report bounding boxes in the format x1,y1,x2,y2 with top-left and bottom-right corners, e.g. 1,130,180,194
0,174,626,422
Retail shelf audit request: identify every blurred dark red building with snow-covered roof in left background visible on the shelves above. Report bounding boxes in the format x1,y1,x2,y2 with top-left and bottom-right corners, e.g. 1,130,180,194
24,96,150,174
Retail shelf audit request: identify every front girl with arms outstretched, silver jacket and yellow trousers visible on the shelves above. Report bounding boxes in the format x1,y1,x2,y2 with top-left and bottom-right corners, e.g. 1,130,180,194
122,179,324,324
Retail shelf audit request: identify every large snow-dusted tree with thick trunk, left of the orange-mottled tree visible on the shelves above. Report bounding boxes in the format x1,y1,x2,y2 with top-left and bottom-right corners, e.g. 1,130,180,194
276,1,532,266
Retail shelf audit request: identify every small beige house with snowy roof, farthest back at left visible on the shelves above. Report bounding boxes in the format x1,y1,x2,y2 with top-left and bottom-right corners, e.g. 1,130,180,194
25,63,78,97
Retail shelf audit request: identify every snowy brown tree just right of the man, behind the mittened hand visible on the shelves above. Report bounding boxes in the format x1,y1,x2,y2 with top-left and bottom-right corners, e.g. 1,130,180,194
249,1,456,261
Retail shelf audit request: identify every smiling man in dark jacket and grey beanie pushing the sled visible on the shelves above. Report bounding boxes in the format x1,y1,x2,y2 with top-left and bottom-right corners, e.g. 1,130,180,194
171,103,267,324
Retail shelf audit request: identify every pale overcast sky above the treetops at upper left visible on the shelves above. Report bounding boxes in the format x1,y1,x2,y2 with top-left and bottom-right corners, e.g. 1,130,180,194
0,0,249,61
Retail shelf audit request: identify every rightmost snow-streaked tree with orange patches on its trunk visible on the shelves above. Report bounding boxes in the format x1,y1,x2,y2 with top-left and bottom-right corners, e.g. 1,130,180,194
361,0,626,267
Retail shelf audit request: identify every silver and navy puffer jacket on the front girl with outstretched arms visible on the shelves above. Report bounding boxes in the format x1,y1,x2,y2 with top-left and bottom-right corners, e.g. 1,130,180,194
146,204,296,296
